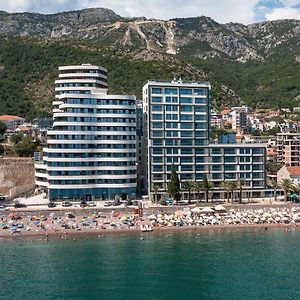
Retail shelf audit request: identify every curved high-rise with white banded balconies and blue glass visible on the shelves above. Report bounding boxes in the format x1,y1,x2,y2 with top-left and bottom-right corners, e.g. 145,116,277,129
36,65,136,200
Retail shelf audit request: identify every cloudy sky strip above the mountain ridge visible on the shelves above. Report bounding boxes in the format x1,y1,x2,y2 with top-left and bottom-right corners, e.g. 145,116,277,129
0,0,300,24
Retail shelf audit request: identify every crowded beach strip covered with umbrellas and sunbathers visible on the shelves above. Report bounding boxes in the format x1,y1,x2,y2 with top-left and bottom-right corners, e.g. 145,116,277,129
0,205,300,239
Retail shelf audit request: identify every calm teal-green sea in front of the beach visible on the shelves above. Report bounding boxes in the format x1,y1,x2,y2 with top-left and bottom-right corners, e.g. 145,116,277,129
0,228,300,300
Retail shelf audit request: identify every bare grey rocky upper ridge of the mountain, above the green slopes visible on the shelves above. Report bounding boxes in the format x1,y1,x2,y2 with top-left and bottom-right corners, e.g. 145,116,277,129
0,8,300,63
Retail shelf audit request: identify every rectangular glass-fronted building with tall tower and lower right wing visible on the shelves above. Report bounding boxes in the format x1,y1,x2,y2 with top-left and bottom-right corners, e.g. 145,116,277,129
143,81,266,199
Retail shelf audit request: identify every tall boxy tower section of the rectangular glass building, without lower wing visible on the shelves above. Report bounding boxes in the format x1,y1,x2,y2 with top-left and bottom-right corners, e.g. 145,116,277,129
143,81,211,190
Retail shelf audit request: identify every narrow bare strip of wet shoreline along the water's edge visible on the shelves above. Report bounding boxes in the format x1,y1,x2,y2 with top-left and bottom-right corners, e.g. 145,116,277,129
0,223,299,240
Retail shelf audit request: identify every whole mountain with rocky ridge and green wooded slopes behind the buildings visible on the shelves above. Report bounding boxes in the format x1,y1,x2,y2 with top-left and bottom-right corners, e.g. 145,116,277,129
0,8,300,118
